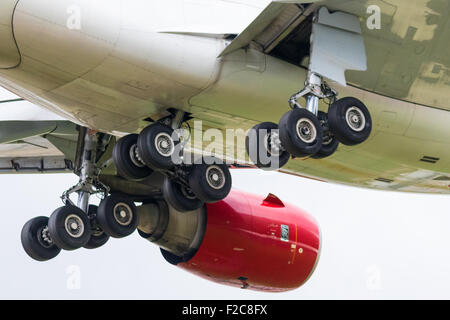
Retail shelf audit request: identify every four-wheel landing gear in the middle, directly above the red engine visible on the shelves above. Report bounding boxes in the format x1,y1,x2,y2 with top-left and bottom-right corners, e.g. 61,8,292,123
113,111,232,212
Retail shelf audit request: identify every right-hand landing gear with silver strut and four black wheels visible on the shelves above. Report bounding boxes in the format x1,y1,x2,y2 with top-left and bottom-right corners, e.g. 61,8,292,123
246,72,372,169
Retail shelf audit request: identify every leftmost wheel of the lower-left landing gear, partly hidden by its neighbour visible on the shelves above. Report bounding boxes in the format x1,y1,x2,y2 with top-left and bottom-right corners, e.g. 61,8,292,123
20,217,61,261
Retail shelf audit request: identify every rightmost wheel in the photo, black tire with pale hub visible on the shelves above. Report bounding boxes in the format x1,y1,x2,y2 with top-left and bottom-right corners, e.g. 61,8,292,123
328,97,372,146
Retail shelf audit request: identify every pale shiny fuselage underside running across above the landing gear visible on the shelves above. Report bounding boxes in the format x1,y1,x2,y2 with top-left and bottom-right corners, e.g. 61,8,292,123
0,0,450,193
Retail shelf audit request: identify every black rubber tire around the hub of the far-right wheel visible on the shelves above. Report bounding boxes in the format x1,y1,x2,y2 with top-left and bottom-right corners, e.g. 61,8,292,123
328,97,372,146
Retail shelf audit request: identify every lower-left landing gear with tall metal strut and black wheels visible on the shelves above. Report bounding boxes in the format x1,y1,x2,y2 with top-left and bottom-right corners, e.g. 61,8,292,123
21,128,139,261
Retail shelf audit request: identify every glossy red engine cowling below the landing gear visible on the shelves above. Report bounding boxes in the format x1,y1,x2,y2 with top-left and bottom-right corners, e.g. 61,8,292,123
178,190,320,292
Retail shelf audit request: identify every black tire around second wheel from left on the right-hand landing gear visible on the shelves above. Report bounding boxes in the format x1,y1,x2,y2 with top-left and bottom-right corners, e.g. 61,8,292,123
279,109,323,157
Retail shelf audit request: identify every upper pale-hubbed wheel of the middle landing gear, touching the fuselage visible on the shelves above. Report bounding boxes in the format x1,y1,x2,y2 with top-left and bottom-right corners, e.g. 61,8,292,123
138,123,176,170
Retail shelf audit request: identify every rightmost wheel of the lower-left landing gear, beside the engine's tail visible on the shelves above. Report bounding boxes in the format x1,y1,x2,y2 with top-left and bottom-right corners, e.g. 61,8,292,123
97,194,139,238
